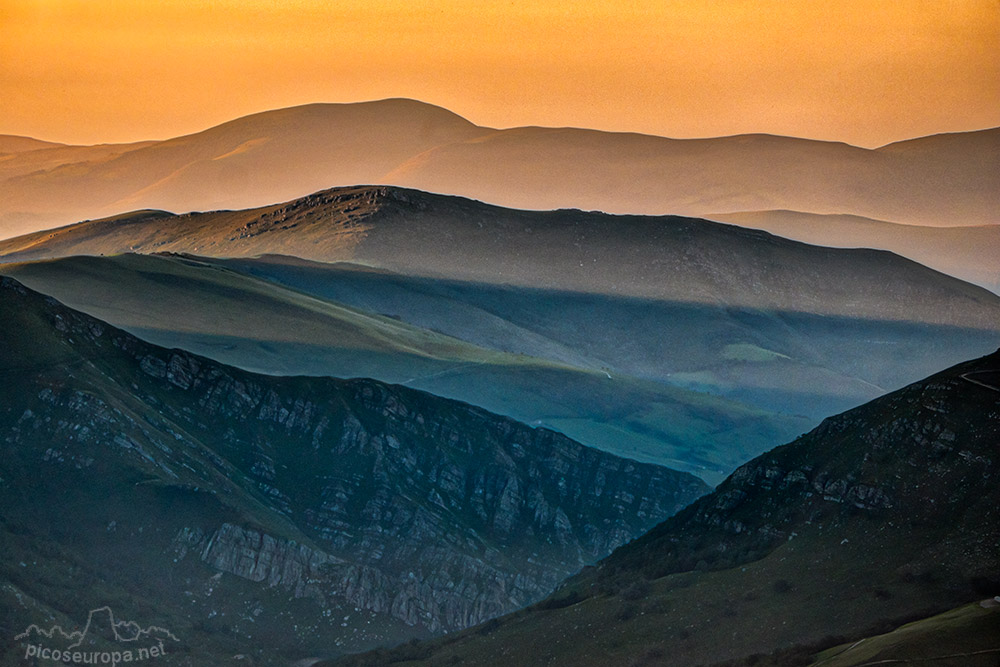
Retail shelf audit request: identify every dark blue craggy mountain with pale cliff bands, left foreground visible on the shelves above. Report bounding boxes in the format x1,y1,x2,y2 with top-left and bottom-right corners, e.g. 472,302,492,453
0,279,706,664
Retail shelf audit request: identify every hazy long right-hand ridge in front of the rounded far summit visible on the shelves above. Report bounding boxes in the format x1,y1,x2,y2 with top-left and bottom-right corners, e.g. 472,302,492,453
389,128,1000,226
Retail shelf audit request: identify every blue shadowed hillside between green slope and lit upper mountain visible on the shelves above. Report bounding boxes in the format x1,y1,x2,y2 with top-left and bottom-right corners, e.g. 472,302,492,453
207,257,1000,419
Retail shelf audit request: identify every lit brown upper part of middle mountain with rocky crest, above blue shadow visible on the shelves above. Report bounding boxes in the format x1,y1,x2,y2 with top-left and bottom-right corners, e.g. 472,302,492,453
0,187,997,327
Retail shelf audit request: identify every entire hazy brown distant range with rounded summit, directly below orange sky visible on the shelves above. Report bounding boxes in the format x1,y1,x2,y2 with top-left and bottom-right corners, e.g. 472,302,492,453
0,99,1000,243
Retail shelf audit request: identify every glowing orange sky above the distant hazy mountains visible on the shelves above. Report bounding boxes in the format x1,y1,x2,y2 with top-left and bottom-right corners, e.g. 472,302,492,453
0,0,1000,146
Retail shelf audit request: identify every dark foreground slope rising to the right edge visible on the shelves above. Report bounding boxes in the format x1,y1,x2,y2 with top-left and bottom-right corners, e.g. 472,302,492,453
336,352,1000,667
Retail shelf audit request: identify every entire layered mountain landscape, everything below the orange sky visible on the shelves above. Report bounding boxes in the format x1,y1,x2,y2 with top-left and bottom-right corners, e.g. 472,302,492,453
0,99,1000,667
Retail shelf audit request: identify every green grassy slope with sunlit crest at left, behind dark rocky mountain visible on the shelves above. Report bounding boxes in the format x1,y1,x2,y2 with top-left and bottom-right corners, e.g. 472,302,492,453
0,255,518,382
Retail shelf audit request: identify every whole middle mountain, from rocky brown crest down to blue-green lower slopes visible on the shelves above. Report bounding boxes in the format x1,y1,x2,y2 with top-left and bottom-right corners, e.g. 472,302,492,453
0,187,1000,483
